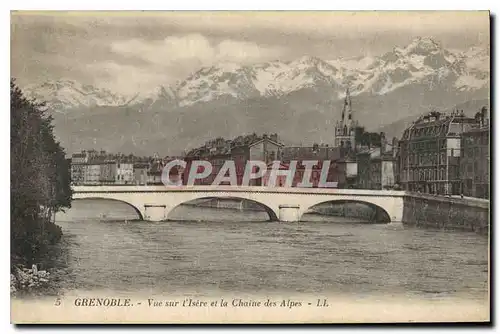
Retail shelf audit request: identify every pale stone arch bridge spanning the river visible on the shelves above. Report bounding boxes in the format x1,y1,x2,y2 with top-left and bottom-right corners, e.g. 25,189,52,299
73,185,405,223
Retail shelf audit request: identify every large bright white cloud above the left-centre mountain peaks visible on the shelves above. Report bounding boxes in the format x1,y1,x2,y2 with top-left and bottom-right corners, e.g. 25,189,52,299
92,34,284,95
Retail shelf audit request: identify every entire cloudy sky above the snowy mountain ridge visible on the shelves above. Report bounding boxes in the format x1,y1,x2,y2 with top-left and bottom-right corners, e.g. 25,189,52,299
11,11,490,95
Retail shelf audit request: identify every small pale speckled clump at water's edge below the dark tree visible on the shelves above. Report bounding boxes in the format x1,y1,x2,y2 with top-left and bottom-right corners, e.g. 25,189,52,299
10,265,50,295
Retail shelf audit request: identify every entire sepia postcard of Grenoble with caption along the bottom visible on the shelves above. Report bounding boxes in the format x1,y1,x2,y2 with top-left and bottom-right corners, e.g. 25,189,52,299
10,11,492,324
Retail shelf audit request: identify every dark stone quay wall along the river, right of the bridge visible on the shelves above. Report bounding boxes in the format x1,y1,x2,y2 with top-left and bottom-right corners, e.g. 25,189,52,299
403,193,490,234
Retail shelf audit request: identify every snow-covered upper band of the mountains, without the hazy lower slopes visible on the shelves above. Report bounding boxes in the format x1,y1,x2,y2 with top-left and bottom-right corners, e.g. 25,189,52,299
22,38,490,111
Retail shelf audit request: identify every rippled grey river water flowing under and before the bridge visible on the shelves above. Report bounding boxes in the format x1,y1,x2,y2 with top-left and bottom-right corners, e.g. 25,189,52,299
46,200,488,300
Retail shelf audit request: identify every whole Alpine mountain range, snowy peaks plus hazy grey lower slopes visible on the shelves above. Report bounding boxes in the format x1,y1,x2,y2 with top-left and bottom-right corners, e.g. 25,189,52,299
22,38,490,154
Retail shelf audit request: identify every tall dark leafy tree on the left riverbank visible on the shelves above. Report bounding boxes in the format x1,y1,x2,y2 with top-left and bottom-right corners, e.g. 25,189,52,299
10,80,72,262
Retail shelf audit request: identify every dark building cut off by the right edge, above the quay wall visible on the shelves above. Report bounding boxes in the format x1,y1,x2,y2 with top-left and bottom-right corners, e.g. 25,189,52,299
460,107,490,198
